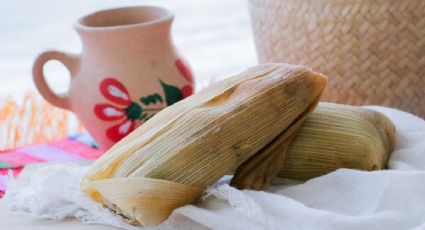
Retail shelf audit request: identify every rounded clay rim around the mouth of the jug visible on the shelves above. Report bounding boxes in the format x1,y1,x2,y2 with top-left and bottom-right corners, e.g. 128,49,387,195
74,5,174,32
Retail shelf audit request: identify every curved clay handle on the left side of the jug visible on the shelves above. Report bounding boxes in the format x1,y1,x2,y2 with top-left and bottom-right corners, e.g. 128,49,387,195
32,51,79,110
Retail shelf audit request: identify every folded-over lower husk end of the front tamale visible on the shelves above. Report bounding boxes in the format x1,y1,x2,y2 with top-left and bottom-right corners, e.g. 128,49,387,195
81,177,203,226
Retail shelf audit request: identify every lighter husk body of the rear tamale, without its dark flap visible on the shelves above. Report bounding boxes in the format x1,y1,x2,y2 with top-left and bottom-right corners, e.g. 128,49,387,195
279,103,395,180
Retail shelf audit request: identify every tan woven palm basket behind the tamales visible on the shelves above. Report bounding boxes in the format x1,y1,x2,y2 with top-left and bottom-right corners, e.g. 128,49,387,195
249,0,425,117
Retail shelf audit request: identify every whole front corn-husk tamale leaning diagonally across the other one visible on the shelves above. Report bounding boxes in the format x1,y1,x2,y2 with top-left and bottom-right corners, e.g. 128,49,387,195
82,64,327,226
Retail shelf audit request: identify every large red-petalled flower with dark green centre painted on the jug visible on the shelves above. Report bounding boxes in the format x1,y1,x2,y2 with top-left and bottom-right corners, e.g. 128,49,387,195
94,78,143,142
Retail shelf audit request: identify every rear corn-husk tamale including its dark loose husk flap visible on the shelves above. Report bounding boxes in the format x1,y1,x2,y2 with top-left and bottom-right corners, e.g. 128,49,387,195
231,103,395,190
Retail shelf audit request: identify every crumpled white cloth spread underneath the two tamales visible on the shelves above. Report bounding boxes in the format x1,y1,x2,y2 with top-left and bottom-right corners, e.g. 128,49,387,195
6,107,425,230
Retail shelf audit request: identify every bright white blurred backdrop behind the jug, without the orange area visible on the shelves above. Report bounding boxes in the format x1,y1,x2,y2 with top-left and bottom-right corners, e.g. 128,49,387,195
0,0,256,100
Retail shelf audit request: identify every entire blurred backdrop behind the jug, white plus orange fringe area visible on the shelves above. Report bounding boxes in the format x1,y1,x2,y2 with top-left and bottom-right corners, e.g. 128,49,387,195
0,0,257,149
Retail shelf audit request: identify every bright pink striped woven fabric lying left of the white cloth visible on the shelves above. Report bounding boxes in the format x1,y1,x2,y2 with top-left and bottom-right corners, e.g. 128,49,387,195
0,135,102,198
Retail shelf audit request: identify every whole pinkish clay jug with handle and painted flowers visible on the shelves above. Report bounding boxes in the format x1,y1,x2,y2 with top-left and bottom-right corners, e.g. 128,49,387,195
33,6,193,150
